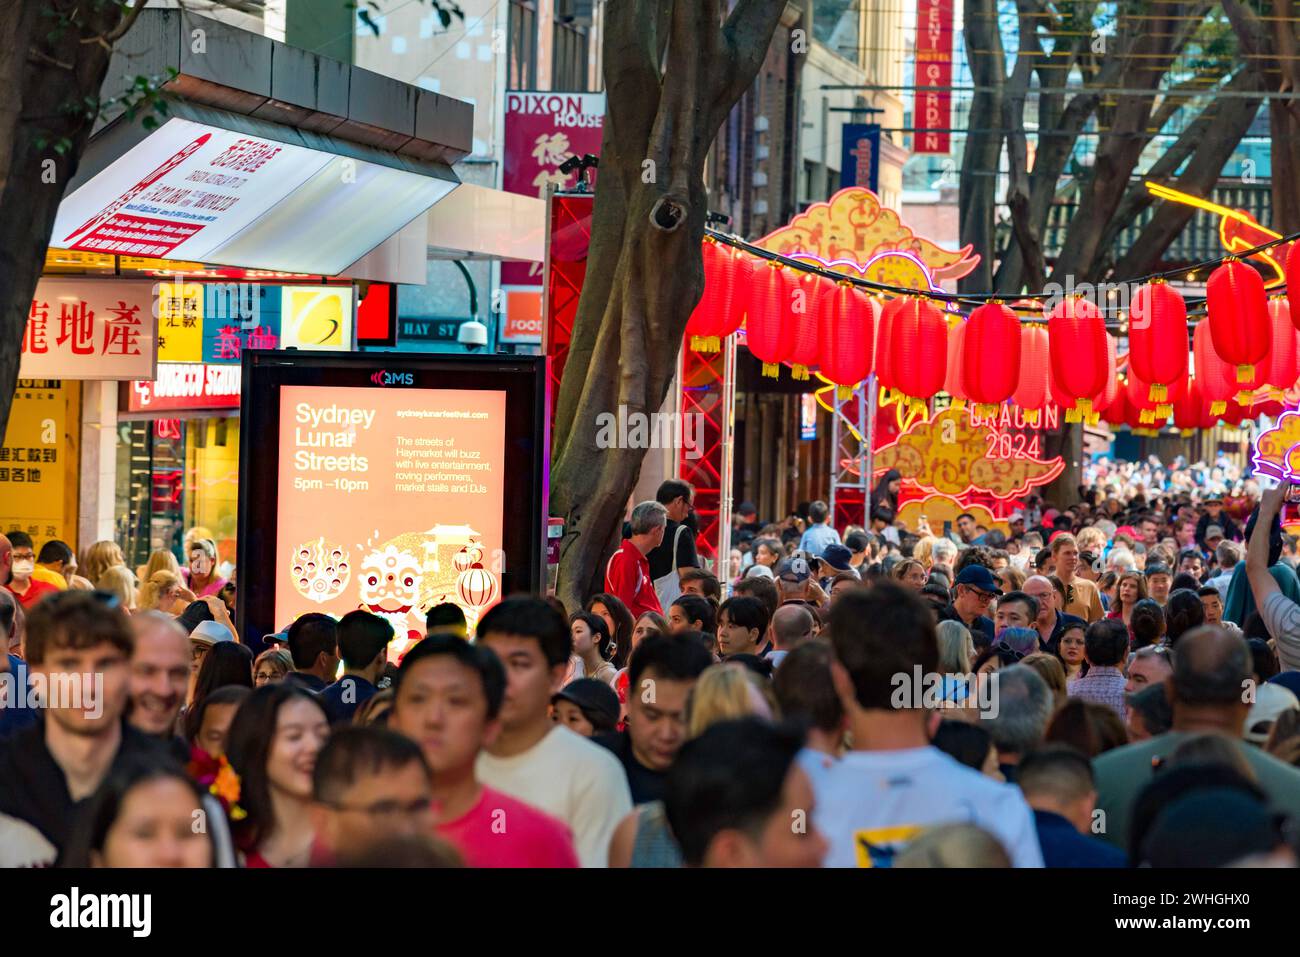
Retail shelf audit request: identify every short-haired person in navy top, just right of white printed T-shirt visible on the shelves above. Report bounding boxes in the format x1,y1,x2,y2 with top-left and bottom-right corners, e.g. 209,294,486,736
1017,745,1127,867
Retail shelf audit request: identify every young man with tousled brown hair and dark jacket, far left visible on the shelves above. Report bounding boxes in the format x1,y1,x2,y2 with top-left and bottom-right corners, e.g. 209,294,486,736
0,589,165,865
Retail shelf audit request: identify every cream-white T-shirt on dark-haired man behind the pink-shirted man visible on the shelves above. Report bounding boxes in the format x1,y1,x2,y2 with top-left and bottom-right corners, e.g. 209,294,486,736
475,724,632,867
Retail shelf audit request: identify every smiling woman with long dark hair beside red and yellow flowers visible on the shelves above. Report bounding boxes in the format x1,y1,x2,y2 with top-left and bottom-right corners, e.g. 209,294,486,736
226,681,329,867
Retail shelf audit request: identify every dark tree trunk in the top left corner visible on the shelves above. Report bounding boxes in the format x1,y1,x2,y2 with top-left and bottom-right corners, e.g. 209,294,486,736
0,0,131,436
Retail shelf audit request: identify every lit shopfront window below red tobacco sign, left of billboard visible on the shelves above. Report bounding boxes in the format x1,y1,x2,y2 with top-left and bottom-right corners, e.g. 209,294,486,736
117,416,239,568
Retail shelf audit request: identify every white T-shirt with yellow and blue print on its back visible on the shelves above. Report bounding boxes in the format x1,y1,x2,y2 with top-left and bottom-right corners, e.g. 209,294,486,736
800,746,1043,867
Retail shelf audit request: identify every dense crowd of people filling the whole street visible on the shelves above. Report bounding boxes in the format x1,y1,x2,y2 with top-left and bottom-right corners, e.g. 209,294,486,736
0,463,1300,867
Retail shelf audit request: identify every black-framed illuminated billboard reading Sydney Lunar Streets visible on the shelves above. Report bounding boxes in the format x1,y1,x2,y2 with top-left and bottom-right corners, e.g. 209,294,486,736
238,351,546,658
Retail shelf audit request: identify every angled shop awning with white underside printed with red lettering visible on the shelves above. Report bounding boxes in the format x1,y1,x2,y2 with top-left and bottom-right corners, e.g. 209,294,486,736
51,9,472,282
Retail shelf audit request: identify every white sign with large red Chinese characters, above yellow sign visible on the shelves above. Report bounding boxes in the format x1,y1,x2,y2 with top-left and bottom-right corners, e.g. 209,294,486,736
18,280,157,380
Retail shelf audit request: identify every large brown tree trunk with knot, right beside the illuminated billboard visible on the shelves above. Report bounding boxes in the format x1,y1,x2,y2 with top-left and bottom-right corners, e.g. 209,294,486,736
551,0,785,607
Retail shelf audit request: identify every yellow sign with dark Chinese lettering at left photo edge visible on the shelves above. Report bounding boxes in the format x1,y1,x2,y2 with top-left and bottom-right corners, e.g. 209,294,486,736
0,378,74,549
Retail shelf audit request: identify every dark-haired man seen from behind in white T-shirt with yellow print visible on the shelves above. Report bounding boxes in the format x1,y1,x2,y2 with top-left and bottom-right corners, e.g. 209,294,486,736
801,582,1050,867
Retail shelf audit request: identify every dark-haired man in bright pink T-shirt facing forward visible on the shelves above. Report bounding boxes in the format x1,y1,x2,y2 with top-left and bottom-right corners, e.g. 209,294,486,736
389,635,579,867
